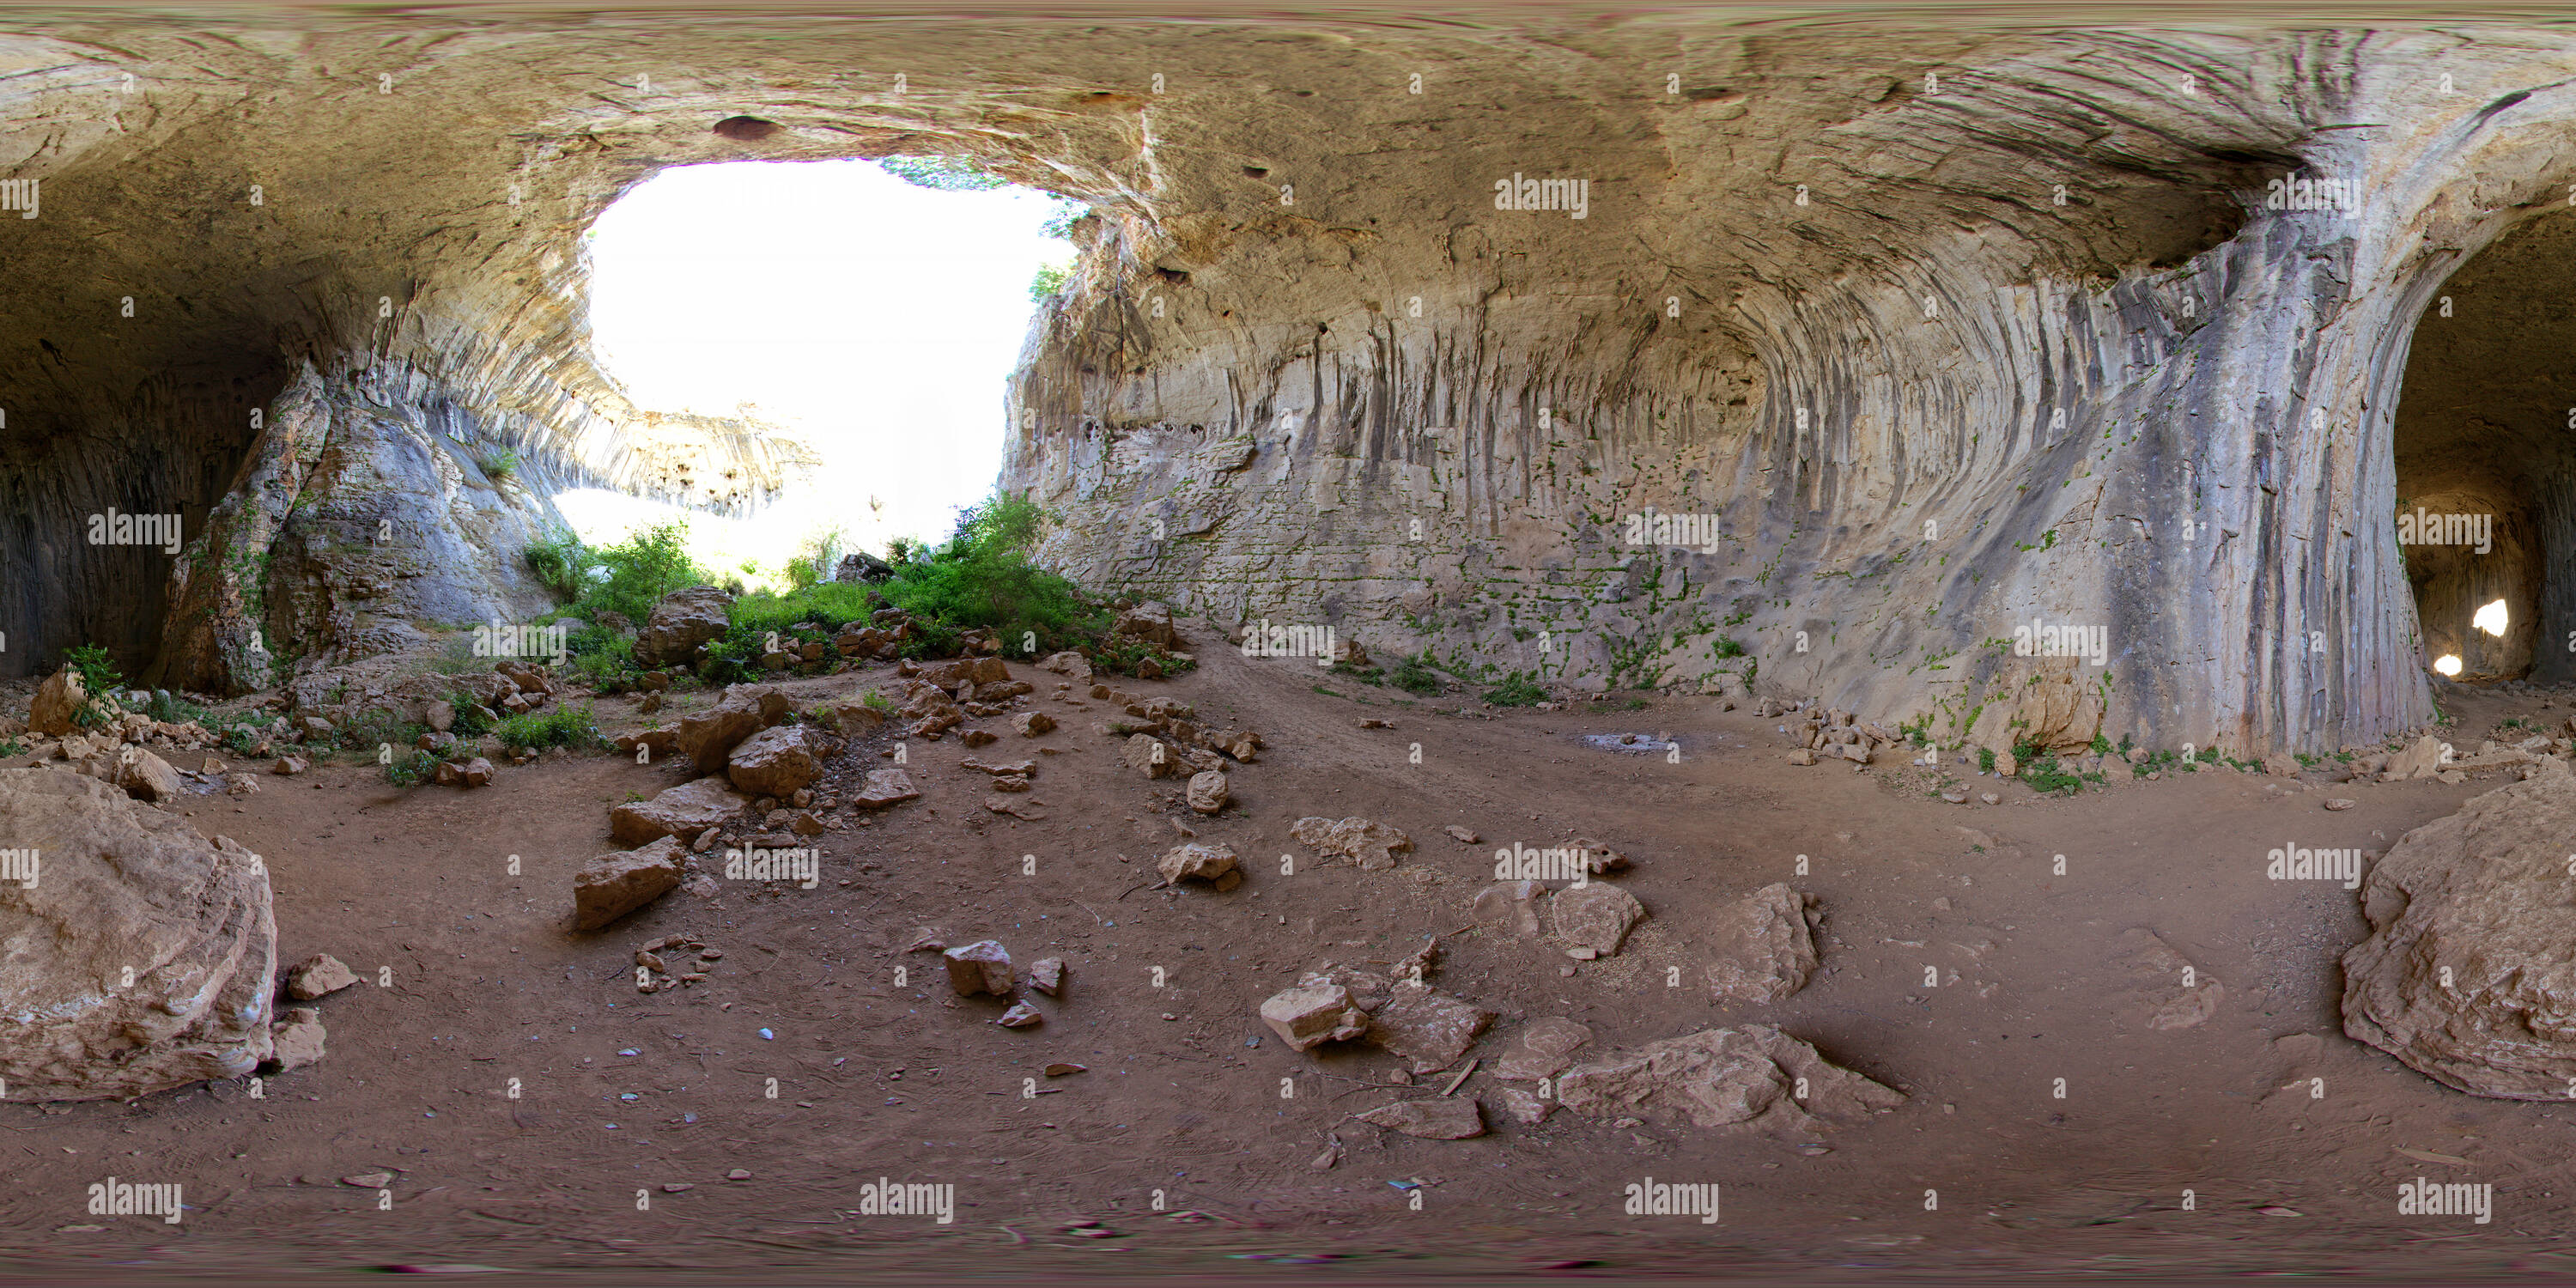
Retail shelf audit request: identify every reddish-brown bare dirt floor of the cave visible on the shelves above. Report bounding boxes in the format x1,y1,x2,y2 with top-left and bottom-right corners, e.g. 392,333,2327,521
0,647,2576,1283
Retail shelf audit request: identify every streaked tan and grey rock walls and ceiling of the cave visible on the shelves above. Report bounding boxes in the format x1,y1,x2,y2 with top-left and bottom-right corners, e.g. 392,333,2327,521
0,10,2576,755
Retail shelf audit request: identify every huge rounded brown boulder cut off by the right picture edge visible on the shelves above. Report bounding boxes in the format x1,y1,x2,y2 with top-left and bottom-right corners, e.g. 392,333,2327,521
2344,760,2576,1100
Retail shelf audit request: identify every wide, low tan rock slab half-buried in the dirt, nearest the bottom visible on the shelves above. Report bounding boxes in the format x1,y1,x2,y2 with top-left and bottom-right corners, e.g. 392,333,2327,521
1556,1025,1904,1128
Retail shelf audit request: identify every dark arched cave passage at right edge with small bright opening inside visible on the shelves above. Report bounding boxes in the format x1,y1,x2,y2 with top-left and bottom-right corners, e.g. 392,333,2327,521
2396,209,2576,683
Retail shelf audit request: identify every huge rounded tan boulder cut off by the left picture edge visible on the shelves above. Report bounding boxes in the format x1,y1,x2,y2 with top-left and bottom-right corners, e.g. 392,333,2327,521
0,770,278,1100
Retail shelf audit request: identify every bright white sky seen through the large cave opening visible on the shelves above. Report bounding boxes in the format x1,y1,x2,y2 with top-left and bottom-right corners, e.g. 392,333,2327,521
556,160,1072,585
